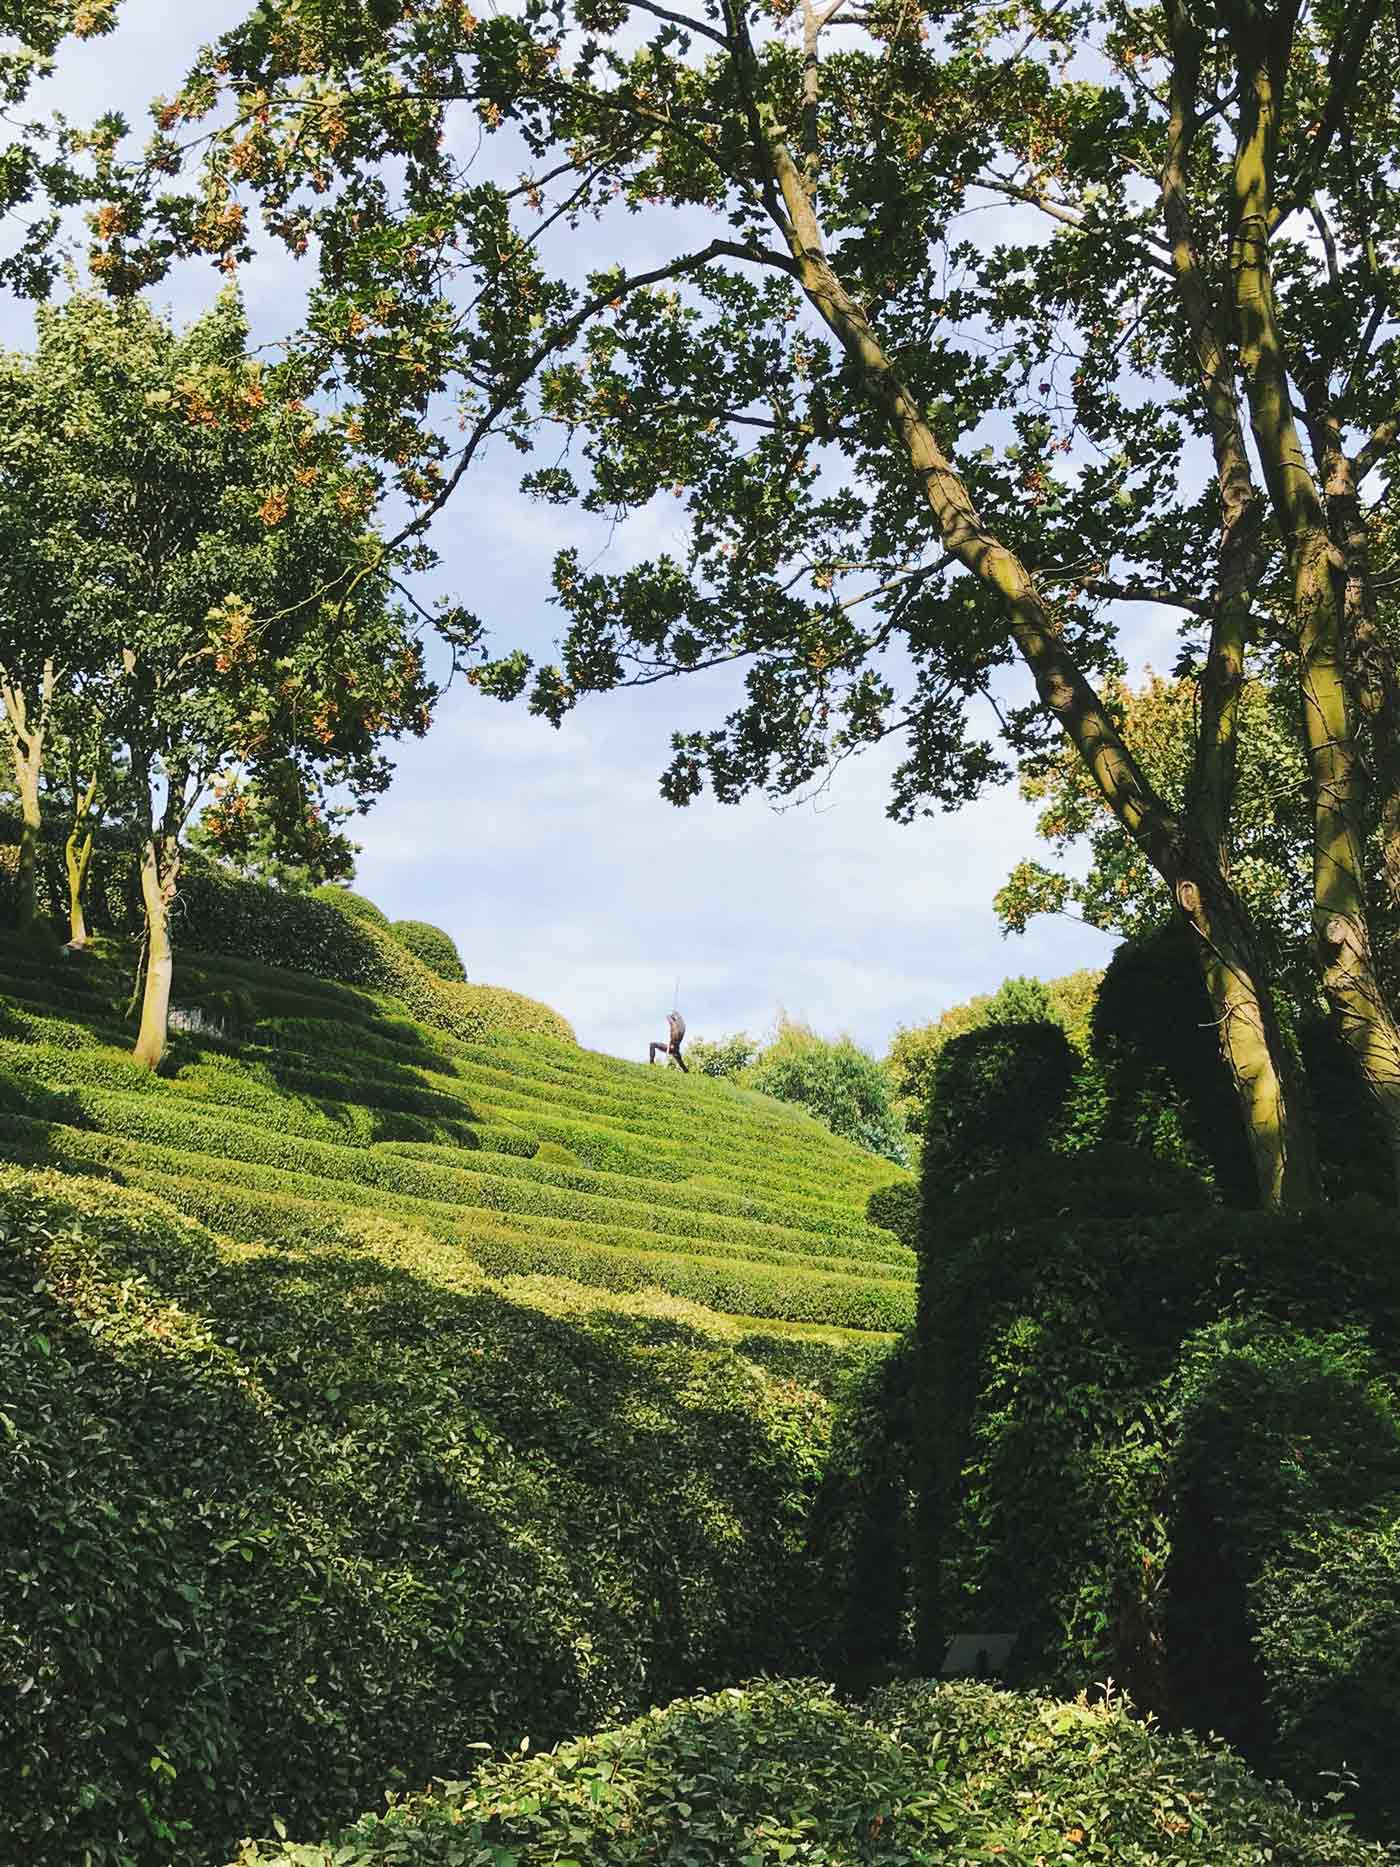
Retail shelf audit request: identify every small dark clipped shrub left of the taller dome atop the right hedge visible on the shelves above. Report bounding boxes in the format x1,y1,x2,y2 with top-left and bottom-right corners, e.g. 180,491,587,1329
926,1021,1077,1180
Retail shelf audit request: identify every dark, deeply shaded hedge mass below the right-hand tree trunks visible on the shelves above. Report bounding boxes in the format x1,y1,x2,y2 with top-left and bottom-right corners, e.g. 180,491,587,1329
918,1150,1400,1830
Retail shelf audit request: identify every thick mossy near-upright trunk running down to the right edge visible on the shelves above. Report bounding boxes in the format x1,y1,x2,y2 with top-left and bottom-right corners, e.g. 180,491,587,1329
1230,32,1400,1189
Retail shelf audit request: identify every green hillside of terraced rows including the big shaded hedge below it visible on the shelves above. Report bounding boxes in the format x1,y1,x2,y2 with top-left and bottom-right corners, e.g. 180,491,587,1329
0,926,913,1867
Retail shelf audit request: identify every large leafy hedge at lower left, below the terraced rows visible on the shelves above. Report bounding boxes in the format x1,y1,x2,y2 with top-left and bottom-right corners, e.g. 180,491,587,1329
0,1169,825,1867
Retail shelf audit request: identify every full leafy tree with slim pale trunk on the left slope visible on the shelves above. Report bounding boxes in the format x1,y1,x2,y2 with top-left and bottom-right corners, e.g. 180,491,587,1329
6,293,449,1066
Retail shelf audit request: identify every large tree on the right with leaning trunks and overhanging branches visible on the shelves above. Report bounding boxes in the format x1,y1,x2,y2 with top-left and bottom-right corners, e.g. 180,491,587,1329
112,0,1400,1206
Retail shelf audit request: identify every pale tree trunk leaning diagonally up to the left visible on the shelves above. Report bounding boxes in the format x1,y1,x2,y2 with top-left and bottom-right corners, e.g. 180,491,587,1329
726,6,1316,1208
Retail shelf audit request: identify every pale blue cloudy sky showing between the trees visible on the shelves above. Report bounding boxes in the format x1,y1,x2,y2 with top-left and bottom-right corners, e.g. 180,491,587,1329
19,0,1142,1057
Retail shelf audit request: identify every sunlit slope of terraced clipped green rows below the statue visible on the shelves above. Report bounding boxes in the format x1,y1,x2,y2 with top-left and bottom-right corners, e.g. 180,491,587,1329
0,945,913,1341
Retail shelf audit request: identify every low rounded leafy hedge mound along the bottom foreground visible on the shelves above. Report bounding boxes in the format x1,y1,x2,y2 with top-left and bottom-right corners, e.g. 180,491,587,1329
237,1680,1389,1867
